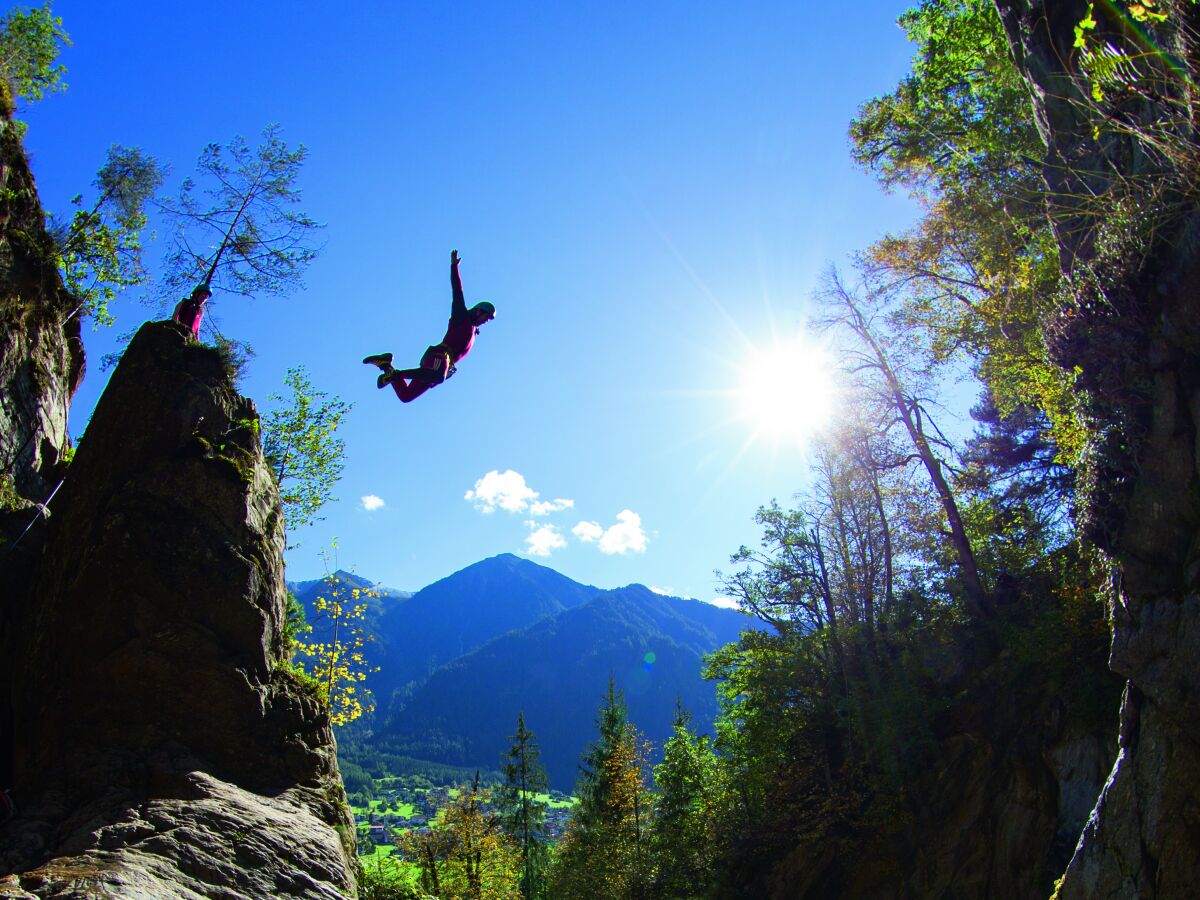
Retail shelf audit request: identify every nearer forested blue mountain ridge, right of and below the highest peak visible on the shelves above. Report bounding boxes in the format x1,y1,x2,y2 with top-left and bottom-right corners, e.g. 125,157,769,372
377,585,750,790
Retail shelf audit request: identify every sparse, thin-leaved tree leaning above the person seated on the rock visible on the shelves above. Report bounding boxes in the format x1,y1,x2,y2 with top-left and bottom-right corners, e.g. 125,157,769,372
160,125,320,303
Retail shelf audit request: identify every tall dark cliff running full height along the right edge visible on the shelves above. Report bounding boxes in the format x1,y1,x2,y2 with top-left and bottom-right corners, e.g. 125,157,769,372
996,0,1200,899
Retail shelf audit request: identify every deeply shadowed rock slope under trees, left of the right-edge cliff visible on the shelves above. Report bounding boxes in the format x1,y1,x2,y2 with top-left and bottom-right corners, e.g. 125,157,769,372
758,633,1117,900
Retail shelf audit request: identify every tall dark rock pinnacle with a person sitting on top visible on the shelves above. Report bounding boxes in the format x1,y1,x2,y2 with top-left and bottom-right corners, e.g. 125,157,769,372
0,322,354,898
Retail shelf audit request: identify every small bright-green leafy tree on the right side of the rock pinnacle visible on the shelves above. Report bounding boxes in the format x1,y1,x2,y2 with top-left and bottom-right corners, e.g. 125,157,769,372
263,366,354,528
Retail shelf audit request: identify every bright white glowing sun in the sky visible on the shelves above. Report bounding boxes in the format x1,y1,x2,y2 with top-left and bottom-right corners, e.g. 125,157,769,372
737,334,836,446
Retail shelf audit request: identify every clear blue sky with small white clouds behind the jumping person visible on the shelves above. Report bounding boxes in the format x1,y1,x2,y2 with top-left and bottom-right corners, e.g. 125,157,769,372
23,0,914,600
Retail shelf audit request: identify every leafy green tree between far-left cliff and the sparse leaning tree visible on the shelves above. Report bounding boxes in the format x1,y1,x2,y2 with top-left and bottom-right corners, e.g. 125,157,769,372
50,145,166,325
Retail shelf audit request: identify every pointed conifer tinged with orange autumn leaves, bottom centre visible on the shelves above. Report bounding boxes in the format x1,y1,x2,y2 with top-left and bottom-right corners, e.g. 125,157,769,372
550,678,652,900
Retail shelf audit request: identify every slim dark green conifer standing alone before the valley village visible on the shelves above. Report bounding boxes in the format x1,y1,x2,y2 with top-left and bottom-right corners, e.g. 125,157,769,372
496,712,550,900
